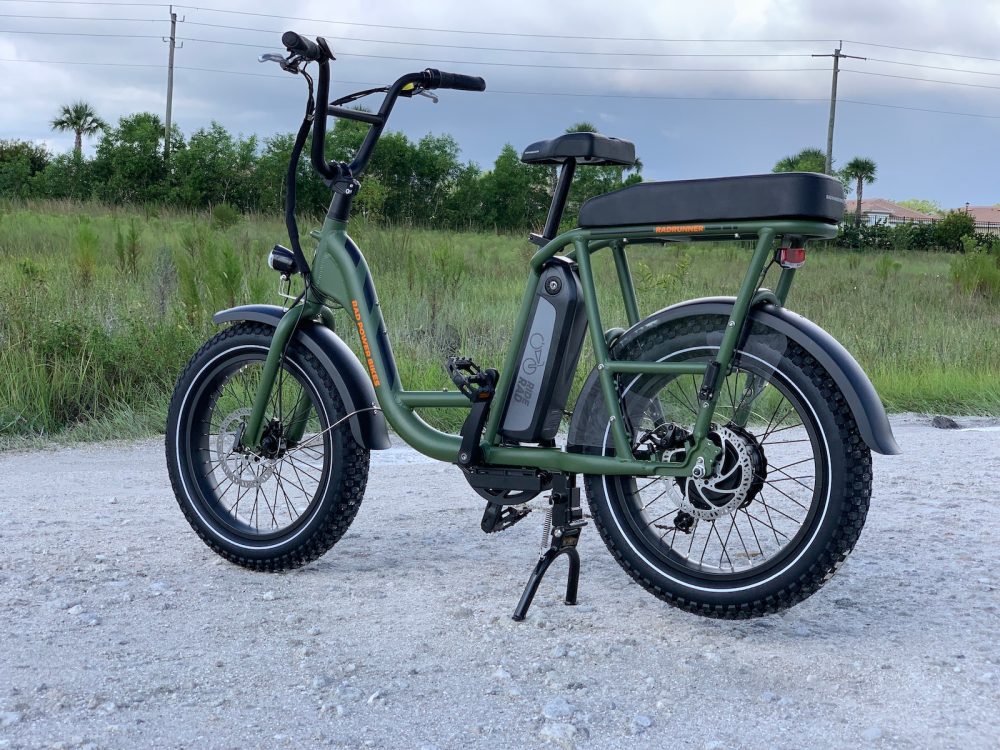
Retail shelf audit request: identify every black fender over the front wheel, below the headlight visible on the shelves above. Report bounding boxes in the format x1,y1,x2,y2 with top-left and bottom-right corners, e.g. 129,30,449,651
212,305,389,450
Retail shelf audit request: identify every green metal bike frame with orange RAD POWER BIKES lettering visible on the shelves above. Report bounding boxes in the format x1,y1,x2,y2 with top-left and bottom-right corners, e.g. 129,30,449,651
244,218,837,476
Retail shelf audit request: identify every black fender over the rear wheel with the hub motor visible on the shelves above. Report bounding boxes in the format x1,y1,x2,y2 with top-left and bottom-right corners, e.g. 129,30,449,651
566,297,901,455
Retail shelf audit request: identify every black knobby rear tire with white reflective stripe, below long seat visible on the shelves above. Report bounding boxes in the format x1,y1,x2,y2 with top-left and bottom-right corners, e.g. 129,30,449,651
585,316,872,619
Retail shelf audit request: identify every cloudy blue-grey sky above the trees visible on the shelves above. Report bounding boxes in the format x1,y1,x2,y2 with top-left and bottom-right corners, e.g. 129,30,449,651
0,0,1000,208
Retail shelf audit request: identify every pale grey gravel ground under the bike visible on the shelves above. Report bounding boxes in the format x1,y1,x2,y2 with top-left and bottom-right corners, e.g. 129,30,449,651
0,416,1000,750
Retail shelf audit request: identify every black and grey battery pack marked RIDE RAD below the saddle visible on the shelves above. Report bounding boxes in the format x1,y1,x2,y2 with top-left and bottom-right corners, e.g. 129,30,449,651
500,257,587,443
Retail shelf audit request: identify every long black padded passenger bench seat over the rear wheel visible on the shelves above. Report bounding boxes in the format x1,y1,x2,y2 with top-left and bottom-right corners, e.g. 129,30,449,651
579,172,844,227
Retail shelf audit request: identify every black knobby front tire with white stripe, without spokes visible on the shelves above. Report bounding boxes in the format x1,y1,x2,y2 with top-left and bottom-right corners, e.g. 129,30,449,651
166,322,369,572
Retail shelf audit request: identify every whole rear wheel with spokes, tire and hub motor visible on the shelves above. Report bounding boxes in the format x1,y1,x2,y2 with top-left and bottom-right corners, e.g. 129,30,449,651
585,316,871,618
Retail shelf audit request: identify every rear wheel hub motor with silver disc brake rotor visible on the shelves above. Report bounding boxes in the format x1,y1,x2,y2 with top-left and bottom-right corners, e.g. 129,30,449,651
677,424,767,521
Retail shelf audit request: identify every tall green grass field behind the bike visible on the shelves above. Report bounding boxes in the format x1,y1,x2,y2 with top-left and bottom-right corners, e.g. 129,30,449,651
0,204,1000,443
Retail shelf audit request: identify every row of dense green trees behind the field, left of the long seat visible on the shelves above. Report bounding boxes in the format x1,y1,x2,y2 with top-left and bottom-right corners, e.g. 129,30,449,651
0,102,641,231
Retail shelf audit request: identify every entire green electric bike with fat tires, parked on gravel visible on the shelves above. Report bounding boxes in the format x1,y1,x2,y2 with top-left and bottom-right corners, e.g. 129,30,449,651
166,32,898,619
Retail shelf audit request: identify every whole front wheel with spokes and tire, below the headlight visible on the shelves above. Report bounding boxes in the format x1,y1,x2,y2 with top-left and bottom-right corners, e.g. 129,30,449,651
166,323,368,571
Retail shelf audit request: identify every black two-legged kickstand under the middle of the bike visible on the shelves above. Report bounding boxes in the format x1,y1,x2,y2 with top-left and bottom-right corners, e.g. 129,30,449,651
512,474,587,622
